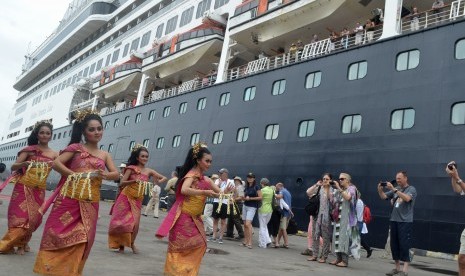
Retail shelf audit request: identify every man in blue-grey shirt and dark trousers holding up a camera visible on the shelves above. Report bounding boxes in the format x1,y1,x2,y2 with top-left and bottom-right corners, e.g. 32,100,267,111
378,171,417,276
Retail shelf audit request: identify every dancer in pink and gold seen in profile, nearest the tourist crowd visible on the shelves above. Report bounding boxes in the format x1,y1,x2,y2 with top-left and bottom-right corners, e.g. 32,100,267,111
156,143,226,276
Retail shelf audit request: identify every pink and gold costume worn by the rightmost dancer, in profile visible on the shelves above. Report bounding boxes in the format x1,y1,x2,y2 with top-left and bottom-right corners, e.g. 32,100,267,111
156,171,210,276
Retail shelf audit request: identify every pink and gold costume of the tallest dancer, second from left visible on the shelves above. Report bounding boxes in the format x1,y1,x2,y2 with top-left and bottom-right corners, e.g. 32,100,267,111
34,144,105,276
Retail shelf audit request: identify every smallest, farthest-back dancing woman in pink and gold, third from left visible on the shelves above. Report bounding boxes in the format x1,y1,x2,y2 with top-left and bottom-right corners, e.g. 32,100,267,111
108,144,167,254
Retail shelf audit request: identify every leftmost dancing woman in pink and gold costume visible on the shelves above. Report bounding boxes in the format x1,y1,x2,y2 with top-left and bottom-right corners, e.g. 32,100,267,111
0,121,58,255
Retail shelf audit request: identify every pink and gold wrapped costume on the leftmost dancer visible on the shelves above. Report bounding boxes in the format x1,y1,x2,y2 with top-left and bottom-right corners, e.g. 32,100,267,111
0,145,53,252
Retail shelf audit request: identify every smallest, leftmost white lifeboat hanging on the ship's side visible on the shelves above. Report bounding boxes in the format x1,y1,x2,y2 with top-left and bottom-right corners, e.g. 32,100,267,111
92,62,142,102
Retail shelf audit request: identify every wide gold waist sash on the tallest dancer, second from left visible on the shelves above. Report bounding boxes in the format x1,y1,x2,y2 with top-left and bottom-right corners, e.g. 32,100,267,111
60,173,102,202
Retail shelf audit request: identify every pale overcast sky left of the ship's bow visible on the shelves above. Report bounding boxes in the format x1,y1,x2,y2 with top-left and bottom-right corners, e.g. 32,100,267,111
0,0,71,136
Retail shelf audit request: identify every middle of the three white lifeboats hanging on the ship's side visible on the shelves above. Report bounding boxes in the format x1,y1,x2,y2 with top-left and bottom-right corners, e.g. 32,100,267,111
142,27,224,85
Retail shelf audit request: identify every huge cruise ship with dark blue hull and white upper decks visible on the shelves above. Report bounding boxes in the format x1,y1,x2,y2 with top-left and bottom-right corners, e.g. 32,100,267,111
0,0,465,253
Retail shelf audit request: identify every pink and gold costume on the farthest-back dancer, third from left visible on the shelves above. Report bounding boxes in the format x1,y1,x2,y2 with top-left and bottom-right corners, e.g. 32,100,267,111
108,166,149,249
